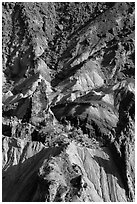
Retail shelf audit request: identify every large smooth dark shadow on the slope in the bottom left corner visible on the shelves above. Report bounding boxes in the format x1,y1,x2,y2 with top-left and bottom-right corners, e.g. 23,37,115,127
2,147,63,202
